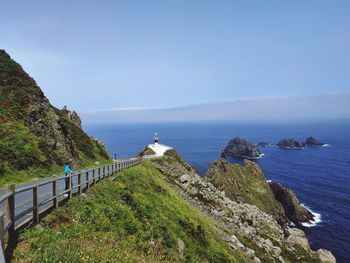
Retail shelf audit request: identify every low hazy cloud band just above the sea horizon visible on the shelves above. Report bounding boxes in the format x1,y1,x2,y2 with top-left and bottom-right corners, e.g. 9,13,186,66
80,93,350,124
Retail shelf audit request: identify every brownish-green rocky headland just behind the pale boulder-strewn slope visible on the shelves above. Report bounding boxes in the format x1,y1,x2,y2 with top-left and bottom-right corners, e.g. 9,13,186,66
204,159,284,219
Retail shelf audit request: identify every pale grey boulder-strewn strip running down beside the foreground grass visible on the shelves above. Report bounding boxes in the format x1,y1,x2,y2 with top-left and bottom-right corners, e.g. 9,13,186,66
152,150,335,263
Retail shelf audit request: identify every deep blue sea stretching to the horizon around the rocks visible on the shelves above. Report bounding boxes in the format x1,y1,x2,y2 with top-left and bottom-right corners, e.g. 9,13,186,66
85,121,350,263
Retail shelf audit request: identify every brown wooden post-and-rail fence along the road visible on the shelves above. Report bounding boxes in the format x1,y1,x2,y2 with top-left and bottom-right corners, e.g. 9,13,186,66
0,158,142,252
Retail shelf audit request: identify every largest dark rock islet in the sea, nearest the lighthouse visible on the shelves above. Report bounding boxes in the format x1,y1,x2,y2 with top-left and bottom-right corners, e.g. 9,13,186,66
223,137,261,159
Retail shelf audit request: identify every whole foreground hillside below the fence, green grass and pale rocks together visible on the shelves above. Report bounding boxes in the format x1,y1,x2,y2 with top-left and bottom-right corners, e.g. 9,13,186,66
14,150,335,263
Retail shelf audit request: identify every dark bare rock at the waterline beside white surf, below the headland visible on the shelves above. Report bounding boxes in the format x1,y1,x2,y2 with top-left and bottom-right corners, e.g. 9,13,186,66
270,183,314,223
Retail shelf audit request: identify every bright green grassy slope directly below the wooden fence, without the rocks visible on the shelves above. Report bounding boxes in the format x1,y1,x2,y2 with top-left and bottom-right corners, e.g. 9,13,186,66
14,162,247,262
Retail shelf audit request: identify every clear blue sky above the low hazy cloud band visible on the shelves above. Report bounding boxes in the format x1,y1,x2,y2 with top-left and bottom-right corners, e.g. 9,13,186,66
0,0,350,120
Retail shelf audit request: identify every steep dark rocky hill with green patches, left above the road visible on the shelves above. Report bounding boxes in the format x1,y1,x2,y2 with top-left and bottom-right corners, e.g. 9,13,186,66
0,50,110,180
